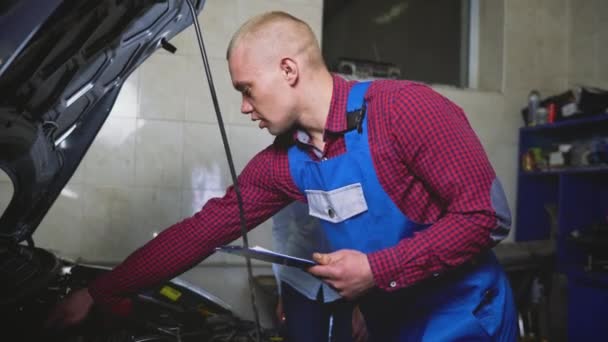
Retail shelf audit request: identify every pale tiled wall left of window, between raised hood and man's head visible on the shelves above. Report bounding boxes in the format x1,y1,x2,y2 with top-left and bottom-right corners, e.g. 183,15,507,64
30,0,322,263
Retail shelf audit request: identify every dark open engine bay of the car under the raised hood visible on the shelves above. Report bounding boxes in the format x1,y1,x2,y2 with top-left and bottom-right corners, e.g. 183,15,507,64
0,248,283,342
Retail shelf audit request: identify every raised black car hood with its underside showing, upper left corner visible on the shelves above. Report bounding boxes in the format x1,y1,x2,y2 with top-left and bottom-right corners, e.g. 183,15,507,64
0,0,205,243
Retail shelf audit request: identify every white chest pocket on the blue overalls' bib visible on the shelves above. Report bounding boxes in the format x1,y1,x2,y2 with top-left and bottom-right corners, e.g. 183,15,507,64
306,183,367,223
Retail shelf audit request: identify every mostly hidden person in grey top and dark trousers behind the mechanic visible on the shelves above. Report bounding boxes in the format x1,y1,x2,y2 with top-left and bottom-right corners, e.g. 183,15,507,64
272,202,365,342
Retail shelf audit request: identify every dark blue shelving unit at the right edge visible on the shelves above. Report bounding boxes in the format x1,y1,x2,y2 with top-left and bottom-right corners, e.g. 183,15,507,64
515,109,608,341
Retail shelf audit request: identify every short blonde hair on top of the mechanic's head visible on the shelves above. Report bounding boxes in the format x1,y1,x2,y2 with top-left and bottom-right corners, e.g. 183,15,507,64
226,11,325,66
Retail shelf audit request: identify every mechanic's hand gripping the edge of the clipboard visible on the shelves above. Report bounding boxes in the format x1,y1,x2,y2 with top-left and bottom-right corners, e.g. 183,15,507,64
308,249,375,299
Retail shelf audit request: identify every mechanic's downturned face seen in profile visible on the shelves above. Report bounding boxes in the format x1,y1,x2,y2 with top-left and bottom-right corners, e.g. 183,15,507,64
228,47,297,135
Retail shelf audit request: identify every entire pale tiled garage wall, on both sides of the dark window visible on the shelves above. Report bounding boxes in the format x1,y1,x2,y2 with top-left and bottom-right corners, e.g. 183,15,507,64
0,0,608,321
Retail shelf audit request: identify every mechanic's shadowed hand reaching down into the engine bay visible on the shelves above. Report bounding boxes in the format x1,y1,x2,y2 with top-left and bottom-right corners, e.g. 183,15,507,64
45,288,93,328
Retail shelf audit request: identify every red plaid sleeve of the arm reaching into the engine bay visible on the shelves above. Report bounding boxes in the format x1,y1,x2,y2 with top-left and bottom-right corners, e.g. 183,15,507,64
89,146,296,311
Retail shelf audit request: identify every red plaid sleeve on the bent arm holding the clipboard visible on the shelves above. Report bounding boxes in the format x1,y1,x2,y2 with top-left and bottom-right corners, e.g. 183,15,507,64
368,84,508,291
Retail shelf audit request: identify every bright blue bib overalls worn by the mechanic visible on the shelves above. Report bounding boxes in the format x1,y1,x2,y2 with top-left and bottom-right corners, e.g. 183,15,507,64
288,82,517,342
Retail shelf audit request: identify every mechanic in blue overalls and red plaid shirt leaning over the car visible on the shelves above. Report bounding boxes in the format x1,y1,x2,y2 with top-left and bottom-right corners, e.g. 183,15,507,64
50,12,516,341
